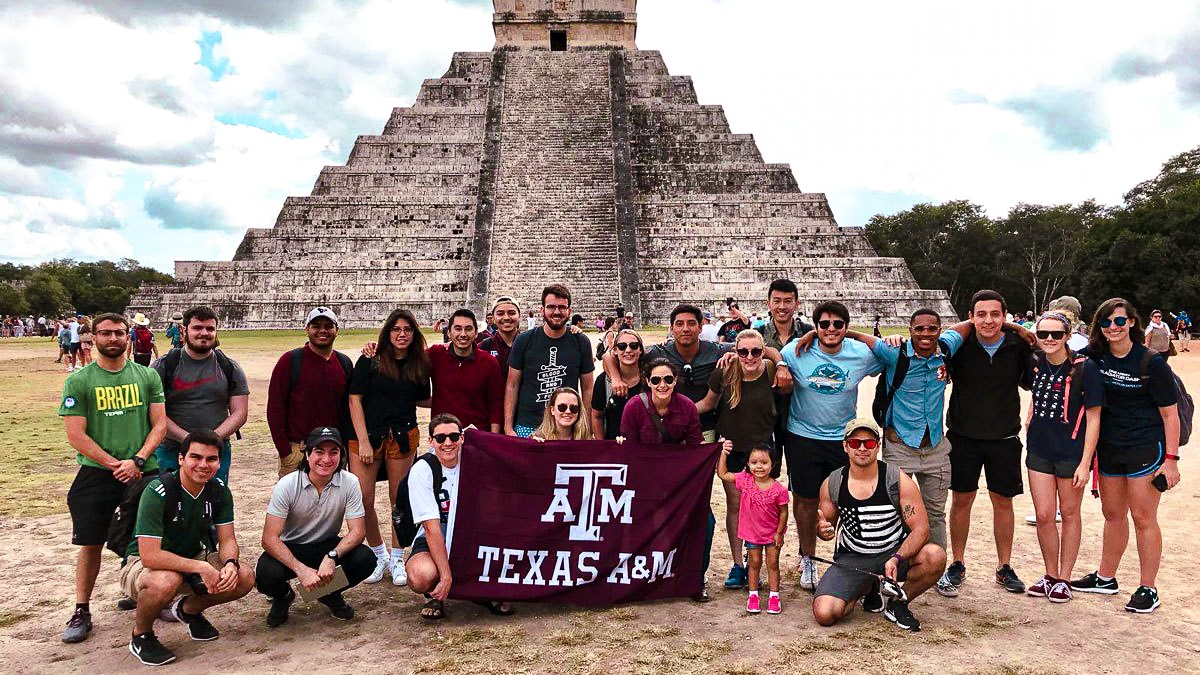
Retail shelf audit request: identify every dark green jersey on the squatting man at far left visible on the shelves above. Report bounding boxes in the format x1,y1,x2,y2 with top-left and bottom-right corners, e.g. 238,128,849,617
125,478,233,557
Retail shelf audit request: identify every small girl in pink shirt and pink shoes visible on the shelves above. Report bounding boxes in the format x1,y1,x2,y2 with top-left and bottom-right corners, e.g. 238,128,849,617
716,441,787,614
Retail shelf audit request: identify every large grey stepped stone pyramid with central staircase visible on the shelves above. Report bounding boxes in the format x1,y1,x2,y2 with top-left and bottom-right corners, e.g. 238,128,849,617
130,0,954,328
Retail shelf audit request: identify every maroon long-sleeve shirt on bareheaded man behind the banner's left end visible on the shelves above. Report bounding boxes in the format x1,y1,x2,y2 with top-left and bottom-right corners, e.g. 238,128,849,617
427,345,504,431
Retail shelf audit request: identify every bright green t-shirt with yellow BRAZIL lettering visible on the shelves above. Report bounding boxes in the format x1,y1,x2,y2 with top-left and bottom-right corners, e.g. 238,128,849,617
59,359,167,471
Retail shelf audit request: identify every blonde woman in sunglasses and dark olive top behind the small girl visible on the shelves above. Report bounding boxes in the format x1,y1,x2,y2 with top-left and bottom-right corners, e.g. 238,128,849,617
696,329,782,591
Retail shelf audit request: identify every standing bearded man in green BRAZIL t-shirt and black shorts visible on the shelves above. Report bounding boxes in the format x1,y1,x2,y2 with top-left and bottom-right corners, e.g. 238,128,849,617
59,313,167,643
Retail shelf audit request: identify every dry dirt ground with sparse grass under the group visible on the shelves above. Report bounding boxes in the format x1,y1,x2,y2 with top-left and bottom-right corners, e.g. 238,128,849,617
0,333,1200,674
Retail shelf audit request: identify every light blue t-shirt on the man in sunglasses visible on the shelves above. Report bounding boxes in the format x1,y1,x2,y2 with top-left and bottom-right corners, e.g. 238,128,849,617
782,340,883,441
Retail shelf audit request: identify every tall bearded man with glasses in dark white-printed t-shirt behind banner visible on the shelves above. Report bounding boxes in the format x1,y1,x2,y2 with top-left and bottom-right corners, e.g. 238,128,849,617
504,283,595,438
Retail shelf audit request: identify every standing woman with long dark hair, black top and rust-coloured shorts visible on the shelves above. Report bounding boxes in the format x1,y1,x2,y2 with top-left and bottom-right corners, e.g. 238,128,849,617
347,310,431,586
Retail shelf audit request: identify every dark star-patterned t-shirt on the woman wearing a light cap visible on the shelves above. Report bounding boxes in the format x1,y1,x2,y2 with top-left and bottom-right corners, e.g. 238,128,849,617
1025,353,1104,461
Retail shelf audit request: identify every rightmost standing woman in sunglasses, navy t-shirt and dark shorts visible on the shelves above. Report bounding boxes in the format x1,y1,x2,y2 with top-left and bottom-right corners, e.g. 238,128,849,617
1070,298,1180,614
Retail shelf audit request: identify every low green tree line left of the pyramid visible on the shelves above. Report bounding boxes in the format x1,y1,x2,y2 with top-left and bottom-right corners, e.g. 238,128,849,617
0,258,174,317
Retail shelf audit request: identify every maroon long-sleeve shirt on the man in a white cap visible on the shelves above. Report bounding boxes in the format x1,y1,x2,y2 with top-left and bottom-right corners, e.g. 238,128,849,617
266,342,353,458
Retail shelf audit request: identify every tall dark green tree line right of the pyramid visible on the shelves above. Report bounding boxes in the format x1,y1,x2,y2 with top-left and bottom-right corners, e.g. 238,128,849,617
866,148,1200,318
